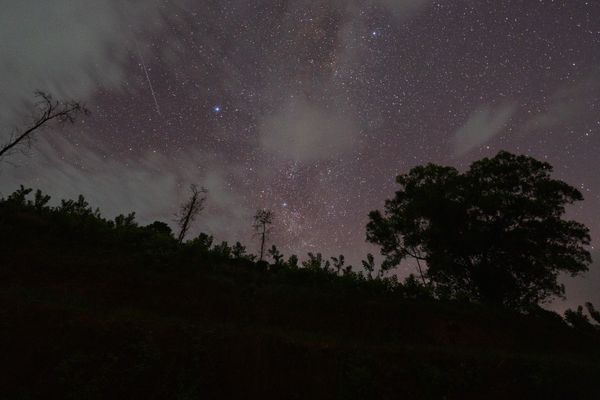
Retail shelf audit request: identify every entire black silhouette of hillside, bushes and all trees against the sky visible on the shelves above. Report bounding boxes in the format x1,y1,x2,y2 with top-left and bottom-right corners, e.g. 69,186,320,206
0,109,600,399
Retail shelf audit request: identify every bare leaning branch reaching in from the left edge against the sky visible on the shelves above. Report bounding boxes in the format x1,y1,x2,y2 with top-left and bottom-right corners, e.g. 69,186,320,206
0,91,89,158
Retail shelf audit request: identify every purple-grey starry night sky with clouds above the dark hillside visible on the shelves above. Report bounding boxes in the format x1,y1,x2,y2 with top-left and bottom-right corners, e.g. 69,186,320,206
0,0,600,306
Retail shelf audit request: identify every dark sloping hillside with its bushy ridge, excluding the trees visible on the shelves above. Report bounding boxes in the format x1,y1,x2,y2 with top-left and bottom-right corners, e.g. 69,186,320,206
0,177,600,399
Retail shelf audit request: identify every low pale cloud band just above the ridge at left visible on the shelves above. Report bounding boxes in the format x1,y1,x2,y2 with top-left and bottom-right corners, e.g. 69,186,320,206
0,138,253,240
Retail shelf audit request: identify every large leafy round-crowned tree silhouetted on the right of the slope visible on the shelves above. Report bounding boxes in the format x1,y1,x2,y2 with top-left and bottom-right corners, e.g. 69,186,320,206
367,151,591,308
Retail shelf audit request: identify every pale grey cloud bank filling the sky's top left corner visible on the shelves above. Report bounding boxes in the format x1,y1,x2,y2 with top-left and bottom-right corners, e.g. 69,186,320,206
0,0,184,125
